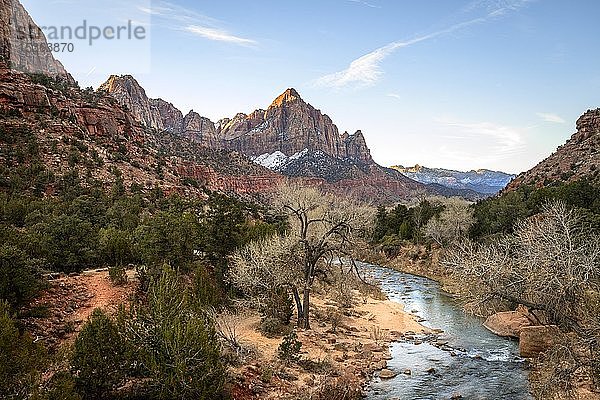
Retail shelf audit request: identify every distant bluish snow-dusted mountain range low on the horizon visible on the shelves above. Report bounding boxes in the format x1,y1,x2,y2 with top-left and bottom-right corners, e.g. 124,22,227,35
391,164,515,195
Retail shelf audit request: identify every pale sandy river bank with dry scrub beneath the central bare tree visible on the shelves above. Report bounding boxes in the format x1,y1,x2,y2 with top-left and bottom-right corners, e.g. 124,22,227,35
231,291,432,399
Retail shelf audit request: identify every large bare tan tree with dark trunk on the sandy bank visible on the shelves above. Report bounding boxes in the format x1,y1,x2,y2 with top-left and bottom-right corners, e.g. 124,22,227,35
231,186,373,329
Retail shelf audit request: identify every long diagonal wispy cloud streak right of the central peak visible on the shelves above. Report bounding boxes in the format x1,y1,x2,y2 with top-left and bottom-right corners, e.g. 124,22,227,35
315,0,532,88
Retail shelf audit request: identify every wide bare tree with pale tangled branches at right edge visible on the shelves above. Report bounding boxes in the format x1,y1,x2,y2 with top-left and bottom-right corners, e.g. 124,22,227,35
444,202,600,398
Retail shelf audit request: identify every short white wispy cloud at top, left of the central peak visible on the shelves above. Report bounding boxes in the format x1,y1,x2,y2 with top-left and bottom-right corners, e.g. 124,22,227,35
139,1,258,46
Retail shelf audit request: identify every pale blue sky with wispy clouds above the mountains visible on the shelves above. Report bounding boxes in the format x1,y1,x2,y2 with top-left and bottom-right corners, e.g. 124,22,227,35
22,0,600,173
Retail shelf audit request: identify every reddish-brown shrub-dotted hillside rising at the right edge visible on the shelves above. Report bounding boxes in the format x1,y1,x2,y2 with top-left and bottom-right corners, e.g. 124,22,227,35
506,108,600,191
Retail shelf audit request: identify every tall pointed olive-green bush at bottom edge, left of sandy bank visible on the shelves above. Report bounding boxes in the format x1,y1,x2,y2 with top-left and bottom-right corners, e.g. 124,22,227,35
126,268,225,399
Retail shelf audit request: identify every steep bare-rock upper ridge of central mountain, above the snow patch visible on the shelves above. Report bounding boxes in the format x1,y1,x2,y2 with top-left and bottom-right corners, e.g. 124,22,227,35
98,75,373,164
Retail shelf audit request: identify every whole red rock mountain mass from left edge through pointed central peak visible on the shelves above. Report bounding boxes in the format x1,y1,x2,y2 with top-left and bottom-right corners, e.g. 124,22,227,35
0,0,478,206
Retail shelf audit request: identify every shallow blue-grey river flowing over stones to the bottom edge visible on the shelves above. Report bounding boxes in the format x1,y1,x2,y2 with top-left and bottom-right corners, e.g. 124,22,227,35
362,264,531,400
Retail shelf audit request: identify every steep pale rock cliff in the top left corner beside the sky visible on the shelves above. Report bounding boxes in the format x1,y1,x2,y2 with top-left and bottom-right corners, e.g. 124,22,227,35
0,0,75,84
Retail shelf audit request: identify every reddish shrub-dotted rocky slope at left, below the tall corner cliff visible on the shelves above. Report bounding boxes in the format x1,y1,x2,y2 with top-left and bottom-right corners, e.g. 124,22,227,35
0,68,284,197
